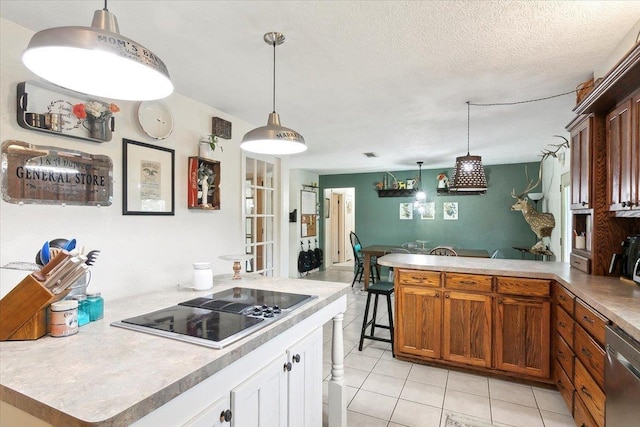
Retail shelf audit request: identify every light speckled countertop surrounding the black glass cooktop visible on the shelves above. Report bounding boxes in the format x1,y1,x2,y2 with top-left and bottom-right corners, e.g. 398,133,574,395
0,275,350,426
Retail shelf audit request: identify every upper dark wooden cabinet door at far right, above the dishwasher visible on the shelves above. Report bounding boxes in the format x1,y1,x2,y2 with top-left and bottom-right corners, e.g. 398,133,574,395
606,99,638,211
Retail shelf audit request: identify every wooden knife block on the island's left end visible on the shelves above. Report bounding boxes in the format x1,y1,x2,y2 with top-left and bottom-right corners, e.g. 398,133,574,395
0,275,69,341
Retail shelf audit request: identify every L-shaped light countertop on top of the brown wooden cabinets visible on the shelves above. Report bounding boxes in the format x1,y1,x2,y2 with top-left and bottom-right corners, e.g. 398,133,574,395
378,254,640,341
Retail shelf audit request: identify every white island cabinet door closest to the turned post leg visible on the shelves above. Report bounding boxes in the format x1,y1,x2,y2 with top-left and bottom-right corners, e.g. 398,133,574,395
287,329,322,427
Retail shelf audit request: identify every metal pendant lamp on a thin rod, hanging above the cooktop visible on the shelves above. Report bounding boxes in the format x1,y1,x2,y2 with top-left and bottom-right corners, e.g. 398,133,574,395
240,32,307,155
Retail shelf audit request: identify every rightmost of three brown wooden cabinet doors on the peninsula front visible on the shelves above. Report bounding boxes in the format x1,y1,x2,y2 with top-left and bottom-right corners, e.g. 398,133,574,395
495,295,551,378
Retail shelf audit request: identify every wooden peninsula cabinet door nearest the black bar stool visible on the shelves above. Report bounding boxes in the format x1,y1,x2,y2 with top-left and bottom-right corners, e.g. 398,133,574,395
395,286,442,359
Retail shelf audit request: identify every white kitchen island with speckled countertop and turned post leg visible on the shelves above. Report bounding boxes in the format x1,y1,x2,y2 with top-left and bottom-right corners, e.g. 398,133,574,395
0,275,350,427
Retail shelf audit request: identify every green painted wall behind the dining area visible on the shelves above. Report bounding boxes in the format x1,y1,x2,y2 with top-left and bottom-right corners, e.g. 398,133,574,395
319,163,541,259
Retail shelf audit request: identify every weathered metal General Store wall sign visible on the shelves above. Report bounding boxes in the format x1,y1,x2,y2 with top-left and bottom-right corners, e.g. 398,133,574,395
0,140,113,206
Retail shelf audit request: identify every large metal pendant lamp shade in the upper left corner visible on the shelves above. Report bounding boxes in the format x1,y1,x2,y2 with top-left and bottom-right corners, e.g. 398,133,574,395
22,0,173,101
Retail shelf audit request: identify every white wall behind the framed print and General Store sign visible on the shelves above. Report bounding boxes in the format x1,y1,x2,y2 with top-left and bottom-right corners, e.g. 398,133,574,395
0,18,260,304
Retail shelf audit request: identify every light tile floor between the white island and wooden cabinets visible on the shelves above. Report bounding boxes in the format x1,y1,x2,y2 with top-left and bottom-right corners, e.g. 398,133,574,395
306,268,574,427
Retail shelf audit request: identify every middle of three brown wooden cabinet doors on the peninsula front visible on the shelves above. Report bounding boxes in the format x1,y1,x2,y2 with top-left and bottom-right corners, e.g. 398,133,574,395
443,292,492,367
